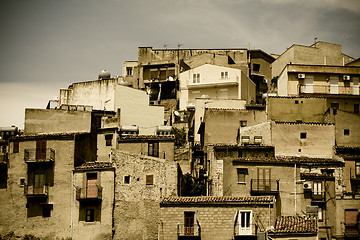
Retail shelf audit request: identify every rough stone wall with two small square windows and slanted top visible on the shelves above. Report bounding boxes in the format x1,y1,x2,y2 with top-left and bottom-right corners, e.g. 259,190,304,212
113,150,177,239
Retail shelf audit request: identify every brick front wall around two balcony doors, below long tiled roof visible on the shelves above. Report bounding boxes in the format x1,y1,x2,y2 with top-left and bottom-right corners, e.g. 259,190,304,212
159,204,275,240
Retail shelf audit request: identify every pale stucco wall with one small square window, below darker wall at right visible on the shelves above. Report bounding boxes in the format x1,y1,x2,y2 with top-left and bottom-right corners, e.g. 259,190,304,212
272,122,335,158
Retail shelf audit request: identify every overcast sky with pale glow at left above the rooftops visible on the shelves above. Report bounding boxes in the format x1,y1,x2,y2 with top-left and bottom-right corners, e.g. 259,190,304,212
0,0,360,128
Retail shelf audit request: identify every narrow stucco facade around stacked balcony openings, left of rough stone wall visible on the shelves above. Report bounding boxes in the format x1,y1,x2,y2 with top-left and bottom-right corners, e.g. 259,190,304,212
72,170,115,240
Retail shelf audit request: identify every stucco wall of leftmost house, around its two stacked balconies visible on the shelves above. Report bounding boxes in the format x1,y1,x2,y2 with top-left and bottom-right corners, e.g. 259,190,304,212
0,140,75,238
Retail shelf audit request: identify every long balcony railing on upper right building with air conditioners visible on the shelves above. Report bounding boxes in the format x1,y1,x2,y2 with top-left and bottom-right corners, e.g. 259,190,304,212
299,85,359,95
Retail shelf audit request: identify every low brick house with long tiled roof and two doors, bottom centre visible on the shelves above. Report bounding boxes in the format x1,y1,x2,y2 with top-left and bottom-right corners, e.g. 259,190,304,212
159,196,276,240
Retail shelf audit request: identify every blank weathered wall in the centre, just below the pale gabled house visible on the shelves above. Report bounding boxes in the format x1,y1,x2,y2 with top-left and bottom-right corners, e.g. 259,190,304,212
204,108,266,144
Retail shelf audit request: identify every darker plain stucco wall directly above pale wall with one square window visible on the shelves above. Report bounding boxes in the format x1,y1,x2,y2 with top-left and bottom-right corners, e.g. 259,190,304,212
268,97,327,122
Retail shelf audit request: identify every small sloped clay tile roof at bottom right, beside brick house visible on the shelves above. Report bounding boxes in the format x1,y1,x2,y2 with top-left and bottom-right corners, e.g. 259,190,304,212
274,216,317,234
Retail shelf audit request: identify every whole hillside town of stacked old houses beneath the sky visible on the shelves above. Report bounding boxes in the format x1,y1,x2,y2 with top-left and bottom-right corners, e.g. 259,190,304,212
0,41,360,240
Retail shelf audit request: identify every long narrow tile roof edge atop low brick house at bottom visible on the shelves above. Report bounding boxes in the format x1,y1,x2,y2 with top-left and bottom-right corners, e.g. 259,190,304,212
161,196,275,204
